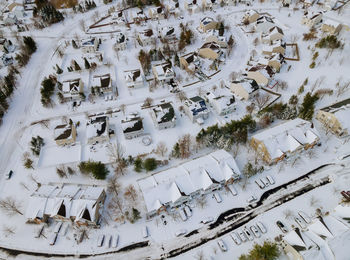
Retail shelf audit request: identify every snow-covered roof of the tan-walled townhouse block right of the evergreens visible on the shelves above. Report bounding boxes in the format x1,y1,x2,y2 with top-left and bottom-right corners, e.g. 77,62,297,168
252,118,319,159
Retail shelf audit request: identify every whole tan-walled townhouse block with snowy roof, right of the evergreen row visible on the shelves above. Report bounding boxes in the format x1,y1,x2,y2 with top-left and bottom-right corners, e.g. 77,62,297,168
250,118,320,164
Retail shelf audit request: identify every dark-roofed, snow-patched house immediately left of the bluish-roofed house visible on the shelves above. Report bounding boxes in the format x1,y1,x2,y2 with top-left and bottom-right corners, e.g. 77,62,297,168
151,102,176,130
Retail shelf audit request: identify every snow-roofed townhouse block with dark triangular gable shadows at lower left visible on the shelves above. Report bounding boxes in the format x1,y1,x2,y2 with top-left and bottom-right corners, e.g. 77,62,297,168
25,184,106,226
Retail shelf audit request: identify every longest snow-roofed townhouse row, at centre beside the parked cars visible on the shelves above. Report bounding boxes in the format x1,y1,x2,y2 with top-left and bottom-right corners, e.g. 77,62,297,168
137,150,241,219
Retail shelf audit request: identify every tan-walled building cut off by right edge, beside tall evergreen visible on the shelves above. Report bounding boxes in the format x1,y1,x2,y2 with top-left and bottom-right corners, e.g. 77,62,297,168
316,98,350,137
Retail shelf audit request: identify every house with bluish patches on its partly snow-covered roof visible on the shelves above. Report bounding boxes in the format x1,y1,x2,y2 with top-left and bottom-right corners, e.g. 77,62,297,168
184,96,209,124
